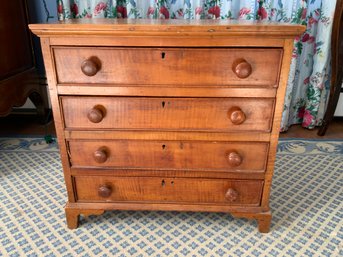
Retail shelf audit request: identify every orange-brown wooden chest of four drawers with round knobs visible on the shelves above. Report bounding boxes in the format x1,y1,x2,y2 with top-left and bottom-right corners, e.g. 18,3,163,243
30,20,304,232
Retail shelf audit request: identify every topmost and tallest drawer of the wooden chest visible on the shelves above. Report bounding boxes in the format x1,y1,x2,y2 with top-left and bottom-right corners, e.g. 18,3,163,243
53,47,282,87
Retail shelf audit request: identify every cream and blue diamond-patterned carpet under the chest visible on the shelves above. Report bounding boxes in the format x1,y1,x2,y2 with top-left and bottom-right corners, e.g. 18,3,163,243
0,138,343,257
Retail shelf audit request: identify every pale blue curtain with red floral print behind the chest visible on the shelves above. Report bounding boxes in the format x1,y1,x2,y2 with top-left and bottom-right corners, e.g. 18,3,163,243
57,0,336,131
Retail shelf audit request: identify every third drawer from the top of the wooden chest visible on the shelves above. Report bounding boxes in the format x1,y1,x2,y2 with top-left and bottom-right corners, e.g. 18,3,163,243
69,140,269,172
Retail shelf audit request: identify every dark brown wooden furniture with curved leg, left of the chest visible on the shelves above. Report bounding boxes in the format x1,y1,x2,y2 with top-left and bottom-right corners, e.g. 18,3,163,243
0,0,49,117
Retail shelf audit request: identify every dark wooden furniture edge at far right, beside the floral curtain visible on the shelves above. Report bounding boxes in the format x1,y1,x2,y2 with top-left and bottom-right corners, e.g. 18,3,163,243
318,0,343,136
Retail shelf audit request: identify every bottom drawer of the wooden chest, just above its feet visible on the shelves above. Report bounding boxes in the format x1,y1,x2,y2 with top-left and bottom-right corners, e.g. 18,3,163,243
74,176,263,205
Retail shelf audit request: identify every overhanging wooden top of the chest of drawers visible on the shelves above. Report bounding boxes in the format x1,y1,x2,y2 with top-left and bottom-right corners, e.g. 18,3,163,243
30,19,304,38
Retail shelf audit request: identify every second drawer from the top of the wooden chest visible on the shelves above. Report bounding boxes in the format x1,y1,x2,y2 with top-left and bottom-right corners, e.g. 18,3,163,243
61,96,274,132
